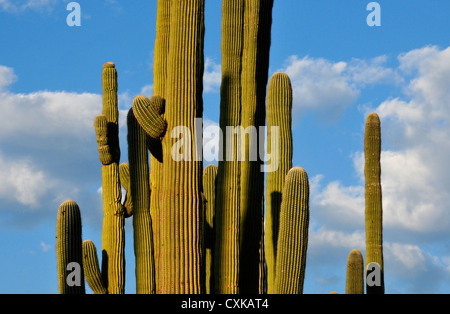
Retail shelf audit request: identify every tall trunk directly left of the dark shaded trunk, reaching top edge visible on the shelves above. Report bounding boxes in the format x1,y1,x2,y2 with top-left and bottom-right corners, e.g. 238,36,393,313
214,0,244,294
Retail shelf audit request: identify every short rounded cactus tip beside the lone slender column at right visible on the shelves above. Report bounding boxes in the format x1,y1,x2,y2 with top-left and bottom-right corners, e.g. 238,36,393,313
345,250,364,294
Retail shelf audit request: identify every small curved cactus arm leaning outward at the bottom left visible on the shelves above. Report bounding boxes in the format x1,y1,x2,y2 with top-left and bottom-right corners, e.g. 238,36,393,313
83,240,108,294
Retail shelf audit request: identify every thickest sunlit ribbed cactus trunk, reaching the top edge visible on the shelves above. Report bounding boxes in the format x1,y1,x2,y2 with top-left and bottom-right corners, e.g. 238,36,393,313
158,0,204,293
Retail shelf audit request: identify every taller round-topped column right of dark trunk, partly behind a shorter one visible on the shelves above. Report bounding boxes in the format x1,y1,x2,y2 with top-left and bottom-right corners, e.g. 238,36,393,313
264,73,293,293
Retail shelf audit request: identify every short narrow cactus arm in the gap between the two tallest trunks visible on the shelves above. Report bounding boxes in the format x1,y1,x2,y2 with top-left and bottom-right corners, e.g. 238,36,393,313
203,165,217,294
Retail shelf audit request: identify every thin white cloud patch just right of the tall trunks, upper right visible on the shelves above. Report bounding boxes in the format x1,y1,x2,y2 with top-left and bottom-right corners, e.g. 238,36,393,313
279,56,403,121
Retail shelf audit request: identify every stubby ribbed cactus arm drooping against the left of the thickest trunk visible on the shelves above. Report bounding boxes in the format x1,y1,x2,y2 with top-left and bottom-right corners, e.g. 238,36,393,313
133,95,167,138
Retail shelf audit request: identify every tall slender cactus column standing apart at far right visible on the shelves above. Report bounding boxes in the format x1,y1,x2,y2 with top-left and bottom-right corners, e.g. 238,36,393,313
364,112,384,294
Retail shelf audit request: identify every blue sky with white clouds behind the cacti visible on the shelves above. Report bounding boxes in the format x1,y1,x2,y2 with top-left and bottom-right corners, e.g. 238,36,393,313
0,0,450,294
